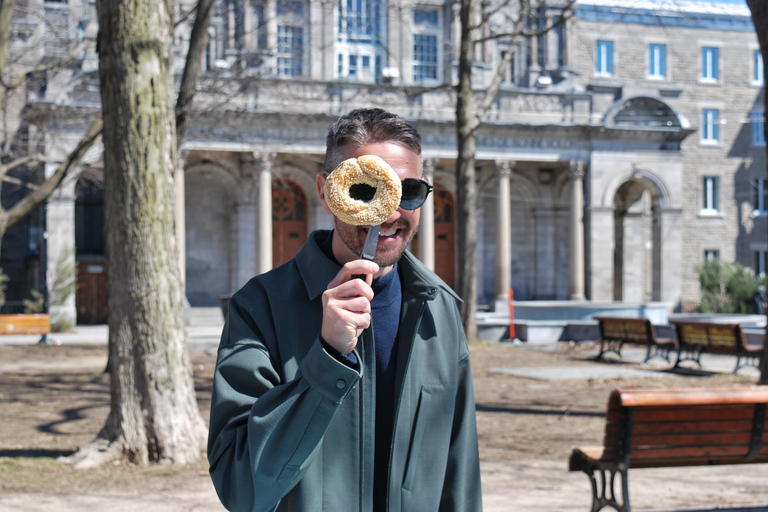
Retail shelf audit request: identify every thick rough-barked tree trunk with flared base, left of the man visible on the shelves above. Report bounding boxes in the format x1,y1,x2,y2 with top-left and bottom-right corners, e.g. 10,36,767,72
73,0,207,467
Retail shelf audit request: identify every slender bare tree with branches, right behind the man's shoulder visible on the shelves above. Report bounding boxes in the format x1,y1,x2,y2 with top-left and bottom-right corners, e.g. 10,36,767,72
456,0,576,340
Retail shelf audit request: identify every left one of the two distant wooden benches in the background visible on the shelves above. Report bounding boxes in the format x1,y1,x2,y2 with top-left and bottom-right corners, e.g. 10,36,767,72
592,316,677,364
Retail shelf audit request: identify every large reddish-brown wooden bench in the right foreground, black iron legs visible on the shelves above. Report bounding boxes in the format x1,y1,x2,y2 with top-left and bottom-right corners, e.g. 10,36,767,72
568,386,768,512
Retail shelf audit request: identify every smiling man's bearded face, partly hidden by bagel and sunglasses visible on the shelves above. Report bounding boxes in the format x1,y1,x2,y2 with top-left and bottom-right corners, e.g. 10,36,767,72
317,142,422,277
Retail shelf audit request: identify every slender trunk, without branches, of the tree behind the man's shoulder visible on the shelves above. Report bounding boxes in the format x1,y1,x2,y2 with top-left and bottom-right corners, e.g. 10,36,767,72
456,0,478,342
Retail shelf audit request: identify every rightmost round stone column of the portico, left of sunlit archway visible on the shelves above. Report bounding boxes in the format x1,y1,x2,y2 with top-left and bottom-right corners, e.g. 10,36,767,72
568,161,584,300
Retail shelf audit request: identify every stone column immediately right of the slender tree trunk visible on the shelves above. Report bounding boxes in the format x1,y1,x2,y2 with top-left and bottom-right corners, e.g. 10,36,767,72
494,160,514,312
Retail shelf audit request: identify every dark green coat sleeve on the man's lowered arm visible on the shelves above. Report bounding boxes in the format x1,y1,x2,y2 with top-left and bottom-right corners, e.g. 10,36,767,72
440,326,483,512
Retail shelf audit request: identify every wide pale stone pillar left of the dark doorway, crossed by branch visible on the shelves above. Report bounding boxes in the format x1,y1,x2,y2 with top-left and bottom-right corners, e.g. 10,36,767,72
43,164,77,326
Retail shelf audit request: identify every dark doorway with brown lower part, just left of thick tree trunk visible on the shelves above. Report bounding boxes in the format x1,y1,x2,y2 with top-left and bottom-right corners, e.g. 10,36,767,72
75,169,107,324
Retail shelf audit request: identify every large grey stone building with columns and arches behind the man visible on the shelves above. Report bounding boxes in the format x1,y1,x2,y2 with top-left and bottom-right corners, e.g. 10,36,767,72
3,0,768,322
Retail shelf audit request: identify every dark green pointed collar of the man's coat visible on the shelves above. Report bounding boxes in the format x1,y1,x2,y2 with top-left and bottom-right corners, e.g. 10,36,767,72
296,230,461,300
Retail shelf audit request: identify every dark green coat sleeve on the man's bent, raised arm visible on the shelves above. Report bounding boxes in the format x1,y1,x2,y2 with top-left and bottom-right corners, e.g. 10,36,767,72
208,295,360,511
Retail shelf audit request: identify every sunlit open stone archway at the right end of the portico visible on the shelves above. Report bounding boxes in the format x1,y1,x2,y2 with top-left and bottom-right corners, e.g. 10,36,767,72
613,178,661,302
